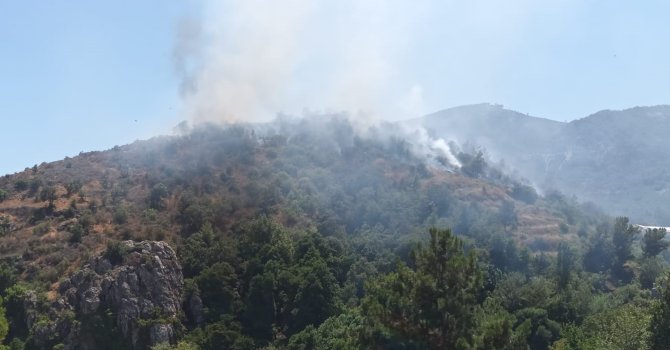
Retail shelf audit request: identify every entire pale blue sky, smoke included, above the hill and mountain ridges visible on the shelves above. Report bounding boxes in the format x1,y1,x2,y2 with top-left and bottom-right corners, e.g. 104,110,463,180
0,0,670,174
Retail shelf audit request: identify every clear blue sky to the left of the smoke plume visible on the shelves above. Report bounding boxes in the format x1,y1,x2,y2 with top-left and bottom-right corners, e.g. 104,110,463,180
0,1,189,173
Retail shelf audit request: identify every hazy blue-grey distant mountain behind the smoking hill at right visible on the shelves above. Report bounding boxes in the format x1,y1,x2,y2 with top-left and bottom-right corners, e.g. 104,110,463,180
426,104,670,226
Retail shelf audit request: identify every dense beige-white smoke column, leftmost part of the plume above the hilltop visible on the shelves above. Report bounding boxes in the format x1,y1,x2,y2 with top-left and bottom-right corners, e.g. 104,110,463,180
175,0,310,122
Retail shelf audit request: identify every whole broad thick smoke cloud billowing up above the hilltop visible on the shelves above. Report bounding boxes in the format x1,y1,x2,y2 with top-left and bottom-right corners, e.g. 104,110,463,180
174,0,424,123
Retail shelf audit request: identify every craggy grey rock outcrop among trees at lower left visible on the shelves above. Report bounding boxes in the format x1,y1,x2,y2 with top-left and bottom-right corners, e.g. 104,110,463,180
30,241,183,349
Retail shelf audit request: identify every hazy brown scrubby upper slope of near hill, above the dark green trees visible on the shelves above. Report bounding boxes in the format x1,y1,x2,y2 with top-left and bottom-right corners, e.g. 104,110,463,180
0,119,594,288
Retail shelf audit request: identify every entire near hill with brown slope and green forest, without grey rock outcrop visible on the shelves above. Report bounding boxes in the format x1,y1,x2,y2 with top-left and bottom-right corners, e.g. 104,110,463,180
0,116,670,350
